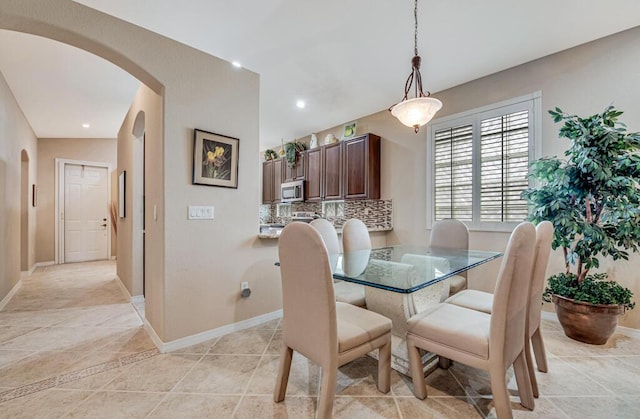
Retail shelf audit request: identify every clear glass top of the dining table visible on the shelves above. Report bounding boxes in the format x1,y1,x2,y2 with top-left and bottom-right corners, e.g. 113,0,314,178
329,245,502,294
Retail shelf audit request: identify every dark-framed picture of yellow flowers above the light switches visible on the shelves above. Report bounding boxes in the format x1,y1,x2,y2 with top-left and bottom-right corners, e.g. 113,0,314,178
193,129,240,188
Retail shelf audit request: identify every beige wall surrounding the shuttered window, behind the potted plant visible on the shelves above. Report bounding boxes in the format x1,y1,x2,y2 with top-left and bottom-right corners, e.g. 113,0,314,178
318,27,640,328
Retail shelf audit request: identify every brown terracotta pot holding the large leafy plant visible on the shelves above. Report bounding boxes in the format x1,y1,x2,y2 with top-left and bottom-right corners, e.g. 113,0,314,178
552,294,624,345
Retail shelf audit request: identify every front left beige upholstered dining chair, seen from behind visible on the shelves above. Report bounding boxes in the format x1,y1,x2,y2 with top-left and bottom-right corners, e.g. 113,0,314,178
273,222,391,419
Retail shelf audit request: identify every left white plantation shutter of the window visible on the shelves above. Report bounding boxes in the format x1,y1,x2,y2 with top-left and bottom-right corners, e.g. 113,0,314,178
434,125,473,221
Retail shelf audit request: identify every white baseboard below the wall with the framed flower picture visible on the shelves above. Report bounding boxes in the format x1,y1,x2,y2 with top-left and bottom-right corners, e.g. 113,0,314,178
151,310,282,353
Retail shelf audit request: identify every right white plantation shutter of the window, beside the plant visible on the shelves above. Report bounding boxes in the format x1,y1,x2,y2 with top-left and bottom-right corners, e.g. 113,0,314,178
480,110,529,222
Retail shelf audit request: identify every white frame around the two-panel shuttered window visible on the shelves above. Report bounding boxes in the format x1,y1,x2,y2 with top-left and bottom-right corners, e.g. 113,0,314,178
426,91,542,232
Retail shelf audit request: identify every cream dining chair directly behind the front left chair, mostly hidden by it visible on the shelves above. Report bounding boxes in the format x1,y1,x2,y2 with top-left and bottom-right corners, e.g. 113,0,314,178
309,218,367,307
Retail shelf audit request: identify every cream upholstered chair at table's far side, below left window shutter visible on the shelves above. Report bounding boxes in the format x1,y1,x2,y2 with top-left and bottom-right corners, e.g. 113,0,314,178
429,218,469,295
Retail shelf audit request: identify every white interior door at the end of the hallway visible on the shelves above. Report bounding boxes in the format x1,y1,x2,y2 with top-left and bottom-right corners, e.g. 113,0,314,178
64,164,109,262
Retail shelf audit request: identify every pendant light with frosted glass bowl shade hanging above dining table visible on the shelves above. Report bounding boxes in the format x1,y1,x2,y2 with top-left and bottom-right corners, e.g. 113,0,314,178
389,0,442,133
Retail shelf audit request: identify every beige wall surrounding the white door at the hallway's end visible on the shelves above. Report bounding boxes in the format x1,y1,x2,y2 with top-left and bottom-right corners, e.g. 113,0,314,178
36,138,117,262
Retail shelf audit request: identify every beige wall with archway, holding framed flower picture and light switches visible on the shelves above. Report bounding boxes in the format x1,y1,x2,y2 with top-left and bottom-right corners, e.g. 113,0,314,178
0,0,281,342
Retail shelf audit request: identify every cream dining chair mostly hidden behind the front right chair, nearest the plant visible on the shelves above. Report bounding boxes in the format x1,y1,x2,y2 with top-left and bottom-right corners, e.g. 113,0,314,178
445,221,553,397
